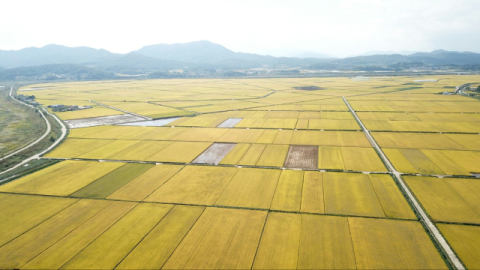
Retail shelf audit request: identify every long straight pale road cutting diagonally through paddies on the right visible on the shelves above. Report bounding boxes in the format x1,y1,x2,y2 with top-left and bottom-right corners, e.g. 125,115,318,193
342,97,465,269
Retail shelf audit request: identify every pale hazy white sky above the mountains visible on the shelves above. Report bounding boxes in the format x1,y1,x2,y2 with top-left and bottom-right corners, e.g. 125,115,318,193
0,0,480,56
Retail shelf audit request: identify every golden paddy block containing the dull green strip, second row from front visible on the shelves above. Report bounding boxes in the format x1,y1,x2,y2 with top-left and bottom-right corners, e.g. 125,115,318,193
0,160,408,219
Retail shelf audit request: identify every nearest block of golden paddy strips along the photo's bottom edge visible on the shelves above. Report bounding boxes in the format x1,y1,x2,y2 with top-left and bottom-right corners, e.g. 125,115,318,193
0,194,447,269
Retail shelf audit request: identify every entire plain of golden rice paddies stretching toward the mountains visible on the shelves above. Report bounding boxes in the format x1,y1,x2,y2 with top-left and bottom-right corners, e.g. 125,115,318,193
0,75,480,269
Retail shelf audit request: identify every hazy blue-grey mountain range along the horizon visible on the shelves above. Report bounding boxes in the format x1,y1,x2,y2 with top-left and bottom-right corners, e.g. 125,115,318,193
0,41,480,79
